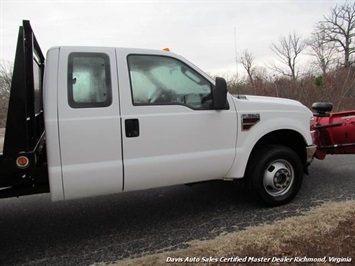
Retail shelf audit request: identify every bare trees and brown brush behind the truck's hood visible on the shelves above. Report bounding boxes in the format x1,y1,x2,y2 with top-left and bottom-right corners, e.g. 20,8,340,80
234,1,355,111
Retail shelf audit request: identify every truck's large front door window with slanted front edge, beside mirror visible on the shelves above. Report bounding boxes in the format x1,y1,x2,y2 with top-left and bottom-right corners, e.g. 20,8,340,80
128,55,212,110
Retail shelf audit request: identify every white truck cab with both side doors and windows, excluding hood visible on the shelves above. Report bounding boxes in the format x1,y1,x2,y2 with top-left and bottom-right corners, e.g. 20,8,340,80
44,47,238,200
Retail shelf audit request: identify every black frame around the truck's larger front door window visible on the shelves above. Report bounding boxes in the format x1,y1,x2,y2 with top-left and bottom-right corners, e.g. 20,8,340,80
126,54,214,111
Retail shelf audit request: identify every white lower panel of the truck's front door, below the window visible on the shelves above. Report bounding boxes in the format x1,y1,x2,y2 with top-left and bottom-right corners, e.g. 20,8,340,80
123,107,235,190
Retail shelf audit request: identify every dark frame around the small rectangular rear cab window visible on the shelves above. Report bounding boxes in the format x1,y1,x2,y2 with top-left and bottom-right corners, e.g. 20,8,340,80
67,52,112,108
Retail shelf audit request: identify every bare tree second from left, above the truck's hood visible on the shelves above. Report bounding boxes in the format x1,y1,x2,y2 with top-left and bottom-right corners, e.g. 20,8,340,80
271,32,306,80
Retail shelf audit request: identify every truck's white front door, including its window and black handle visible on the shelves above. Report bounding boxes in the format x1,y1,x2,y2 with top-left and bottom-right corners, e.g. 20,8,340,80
117,50,237,191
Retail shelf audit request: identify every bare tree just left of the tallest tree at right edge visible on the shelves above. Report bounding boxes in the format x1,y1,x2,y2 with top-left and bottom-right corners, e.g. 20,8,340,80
307,31,338,75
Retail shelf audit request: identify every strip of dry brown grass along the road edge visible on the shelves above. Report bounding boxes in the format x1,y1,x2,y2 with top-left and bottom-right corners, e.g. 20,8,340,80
97,200,355,266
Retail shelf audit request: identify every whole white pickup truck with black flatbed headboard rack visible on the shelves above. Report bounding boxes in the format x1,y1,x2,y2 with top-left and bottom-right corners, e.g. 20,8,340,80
0,21,316,206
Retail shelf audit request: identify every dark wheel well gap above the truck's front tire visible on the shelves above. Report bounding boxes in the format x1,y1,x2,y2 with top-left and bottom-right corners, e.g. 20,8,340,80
253,129,307,164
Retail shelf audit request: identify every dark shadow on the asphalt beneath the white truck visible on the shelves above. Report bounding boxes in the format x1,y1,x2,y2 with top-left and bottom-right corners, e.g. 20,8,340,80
0,181,260,265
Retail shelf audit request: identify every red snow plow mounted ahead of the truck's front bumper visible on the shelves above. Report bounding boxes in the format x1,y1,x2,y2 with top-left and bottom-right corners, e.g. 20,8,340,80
312,102,355,160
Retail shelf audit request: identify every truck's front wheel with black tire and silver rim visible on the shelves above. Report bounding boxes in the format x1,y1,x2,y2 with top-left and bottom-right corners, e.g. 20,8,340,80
246,145,303,207
